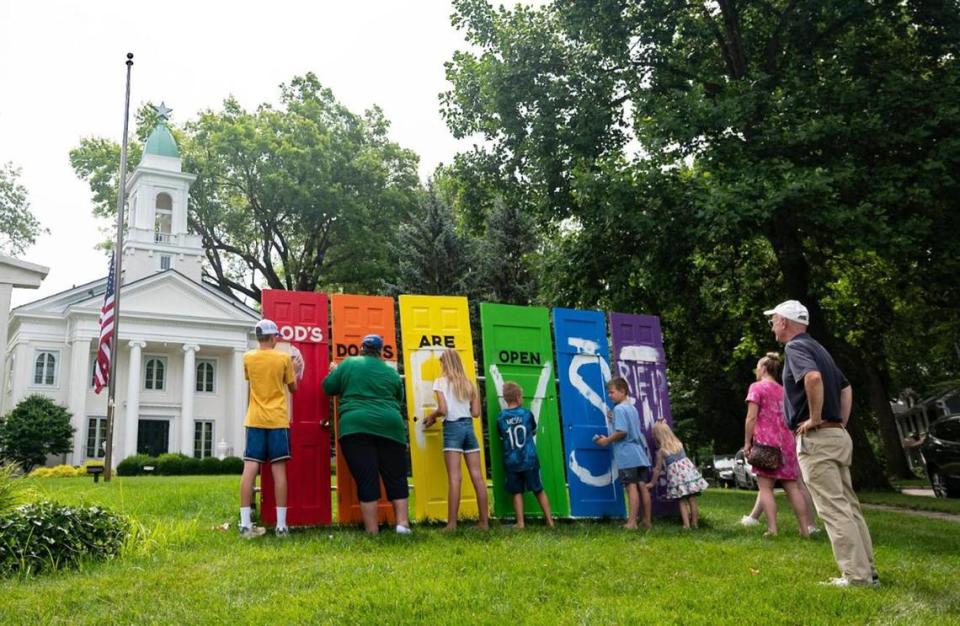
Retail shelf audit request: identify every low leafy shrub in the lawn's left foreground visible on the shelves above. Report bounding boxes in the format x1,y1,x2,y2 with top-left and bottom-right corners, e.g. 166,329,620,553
0,502,130,575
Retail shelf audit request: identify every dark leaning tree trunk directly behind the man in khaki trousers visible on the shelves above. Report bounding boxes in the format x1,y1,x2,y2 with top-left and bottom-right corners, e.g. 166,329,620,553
767,215,891,489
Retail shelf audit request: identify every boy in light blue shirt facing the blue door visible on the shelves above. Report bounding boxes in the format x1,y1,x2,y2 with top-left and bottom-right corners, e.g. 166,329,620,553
593,377,651,529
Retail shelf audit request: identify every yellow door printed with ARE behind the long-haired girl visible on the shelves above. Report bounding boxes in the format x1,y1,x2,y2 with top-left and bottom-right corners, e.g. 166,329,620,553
400,296,486,520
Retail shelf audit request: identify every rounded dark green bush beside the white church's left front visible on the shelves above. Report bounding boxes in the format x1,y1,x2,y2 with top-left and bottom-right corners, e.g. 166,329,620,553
0,394,74,472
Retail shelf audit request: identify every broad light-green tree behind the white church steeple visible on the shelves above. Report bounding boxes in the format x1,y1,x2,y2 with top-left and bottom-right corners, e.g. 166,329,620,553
71,74,419,300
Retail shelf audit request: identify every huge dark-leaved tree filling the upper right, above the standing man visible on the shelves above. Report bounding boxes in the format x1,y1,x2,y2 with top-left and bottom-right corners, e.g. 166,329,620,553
443,0,960,484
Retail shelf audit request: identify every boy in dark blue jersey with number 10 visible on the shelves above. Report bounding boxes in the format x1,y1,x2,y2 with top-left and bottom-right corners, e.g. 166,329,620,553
497,381,553,528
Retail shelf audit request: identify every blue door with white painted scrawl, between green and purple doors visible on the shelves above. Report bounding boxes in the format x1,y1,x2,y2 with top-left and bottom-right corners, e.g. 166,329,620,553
553,308,625,517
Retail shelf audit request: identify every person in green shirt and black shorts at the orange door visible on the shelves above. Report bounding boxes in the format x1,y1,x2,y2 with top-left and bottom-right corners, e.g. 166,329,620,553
323,335,410,535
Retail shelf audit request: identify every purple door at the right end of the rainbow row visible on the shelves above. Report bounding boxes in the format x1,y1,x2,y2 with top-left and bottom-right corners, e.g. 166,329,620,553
610,313,679,515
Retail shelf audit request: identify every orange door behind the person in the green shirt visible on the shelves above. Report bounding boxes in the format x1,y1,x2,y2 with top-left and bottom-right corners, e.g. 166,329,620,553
330,294,397,524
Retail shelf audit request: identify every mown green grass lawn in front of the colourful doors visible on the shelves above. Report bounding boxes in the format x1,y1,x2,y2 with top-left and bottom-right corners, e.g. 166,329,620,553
0,476,960,625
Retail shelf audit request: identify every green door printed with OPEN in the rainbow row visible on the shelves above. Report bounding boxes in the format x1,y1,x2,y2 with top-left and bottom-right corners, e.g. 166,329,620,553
480,302,570,517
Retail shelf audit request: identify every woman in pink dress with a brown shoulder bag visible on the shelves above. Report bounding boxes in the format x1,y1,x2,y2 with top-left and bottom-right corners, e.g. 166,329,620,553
743,352,813,537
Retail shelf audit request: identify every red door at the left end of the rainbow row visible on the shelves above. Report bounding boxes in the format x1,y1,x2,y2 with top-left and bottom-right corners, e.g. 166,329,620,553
260,289,331,526
